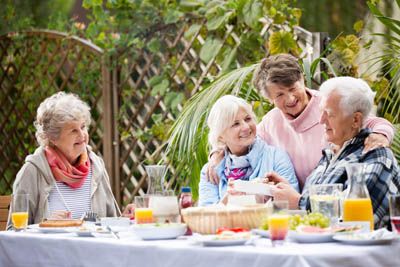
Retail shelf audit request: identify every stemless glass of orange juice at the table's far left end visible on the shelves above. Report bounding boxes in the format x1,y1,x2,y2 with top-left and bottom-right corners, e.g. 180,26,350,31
11,194,29,231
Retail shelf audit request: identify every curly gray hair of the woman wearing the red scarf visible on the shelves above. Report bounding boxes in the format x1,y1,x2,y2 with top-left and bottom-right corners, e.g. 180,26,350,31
34,92,91,146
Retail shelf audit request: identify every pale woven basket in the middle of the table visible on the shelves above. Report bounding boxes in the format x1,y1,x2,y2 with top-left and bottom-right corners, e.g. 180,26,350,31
181,204,268,234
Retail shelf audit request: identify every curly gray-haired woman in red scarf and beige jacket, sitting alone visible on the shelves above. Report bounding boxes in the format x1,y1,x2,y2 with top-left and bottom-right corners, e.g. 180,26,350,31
13,92,119,224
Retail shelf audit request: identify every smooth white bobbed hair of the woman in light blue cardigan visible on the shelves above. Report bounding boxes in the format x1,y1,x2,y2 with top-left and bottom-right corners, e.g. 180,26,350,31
207,95,256,149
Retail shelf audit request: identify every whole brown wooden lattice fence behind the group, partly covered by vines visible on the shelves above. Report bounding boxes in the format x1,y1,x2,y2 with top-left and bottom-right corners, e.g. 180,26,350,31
0,21,322,208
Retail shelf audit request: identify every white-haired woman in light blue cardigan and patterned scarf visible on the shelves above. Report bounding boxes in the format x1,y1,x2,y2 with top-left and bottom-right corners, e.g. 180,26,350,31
199,95,299,206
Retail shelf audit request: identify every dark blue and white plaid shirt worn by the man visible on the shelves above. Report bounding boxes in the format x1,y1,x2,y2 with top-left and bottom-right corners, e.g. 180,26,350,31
299,129,400,229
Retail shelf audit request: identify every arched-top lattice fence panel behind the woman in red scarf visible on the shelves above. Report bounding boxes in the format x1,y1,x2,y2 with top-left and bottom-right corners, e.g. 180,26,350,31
0,31,111,194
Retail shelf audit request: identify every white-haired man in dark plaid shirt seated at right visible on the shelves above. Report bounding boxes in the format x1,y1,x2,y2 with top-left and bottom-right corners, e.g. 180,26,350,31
272,77,400,228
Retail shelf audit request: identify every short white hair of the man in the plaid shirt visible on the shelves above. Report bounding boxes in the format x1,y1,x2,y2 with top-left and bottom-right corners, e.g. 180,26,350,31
319,77,376,118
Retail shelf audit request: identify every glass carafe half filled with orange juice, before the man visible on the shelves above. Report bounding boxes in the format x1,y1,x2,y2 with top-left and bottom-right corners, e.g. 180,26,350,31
343,163,374,231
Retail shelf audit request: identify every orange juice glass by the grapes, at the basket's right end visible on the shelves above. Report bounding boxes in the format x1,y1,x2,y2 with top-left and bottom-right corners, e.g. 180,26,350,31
268,200,289,246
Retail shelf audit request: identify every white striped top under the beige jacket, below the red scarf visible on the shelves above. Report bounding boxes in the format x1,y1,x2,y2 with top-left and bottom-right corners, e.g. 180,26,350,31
49,168,92,219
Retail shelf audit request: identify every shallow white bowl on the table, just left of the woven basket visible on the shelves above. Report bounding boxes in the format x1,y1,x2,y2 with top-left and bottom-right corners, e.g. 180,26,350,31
131,223,187,240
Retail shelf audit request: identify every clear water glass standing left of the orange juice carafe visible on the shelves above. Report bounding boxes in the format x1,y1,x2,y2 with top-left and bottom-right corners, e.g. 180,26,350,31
310,184,343,224
